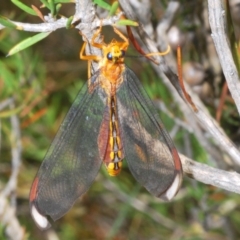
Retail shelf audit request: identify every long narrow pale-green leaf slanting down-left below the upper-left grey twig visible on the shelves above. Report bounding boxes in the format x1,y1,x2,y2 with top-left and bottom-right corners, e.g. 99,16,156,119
7,32,51,57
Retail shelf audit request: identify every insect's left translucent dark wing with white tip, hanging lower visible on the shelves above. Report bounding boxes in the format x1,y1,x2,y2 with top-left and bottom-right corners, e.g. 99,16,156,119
30,73,105,228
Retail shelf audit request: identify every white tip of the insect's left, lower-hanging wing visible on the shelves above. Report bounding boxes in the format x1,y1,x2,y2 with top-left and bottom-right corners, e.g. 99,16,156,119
30,201,51,230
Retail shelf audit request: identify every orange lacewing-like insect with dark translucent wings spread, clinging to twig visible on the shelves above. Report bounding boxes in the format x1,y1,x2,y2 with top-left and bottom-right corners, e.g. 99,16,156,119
30,25,182,229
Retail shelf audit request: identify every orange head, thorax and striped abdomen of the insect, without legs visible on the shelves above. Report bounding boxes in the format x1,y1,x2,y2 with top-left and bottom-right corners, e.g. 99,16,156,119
98,39,128,176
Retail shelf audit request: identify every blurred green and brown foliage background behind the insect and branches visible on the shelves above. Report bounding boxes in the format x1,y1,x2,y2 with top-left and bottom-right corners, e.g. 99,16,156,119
0,0,240,240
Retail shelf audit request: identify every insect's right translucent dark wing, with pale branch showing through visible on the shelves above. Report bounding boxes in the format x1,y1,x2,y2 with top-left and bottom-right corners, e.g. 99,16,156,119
117,67,182,200
